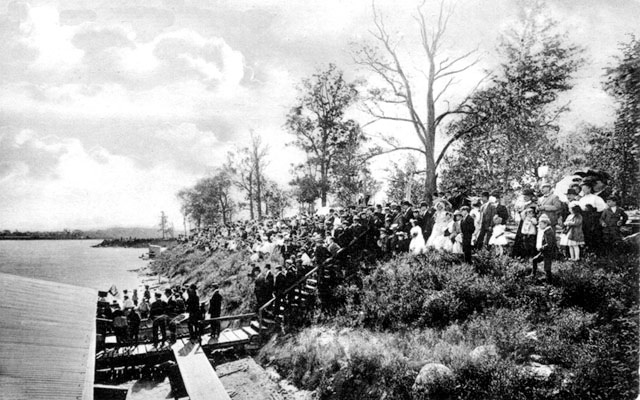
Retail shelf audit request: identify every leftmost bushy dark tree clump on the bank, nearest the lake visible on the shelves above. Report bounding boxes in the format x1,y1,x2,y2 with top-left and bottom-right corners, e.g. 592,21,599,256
178,169,235,227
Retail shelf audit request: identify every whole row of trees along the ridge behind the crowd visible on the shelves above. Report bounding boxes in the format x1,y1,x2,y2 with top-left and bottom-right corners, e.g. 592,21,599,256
178,2,640,226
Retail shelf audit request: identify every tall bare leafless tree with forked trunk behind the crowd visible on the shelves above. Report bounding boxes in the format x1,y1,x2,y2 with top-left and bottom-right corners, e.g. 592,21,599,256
354,0,484,200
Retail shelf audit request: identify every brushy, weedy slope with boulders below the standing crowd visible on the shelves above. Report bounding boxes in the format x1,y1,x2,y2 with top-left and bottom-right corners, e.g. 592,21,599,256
259,248,638,399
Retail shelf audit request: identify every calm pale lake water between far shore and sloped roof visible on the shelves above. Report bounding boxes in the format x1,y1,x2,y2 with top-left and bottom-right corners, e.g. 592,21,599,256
0,240,148,290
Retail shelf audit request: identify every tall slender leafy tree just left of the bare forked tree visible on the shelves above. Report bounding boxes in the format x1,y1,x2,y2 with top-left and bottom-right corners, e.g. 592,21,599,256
285,64,363,206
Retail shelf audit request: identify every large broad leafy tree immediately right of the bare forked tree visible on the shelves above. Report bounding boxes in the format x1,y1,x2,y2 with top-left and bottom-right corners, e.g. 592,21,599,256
442,6,582,189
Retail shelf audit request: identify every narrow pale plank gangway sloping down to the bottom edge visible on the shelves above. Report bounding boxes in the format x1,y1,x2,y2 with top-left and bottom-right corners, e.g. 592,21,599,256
171,341,231,400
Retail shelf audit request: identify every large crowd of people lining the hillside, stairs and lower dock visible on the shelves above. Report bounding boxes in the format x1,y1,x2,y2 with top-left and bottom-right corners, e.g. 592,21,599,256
99,175,627,343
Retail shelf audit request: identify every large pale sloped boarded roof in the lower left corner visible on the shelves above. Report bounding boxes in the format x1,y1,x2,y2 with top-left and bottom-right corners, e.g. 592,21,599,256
0,272,97,400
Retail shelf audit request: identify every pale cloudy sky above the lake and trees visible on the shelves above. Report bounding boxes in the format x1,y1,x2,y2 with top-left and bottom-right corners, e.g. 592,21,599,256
0,0,640,230
